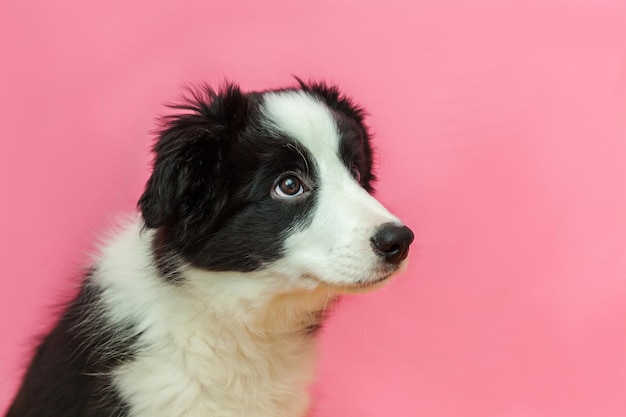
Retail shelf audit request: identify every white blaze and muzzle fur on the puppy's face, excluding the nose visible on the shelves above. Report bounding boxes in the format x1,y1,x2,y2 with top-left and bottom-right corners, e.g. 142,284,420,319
263,91,400,290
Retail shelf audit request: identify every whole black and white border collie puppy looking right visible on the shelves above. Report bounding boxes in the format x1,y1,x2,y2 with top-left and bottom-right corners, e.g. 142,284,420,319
7,81,413,417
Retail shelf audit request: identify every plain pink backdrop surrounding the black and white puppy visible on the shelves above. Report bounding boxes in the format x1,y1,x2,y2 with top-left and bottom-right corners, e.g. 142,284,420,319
0,0,626,417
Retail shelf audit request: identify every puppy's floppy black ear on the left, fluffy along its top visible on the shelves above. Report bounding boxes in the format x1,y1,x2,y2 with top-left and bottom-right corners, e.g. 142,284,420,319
138,84,247,229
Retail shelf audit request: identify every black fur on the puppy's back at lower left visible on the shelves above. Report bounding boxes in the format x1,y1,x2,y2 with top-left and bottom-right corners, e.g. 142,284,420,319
6,272,138,417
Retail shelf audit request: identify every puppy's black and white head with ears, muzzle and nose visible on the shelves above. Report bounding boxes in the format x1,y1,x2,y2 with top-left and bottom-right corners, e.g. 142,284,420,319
139,82,413,291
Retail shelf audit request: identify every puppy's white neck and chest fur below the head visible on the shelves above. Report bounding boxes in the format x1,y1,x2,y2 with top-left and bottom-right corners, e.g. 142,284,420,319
96,224,329,417
